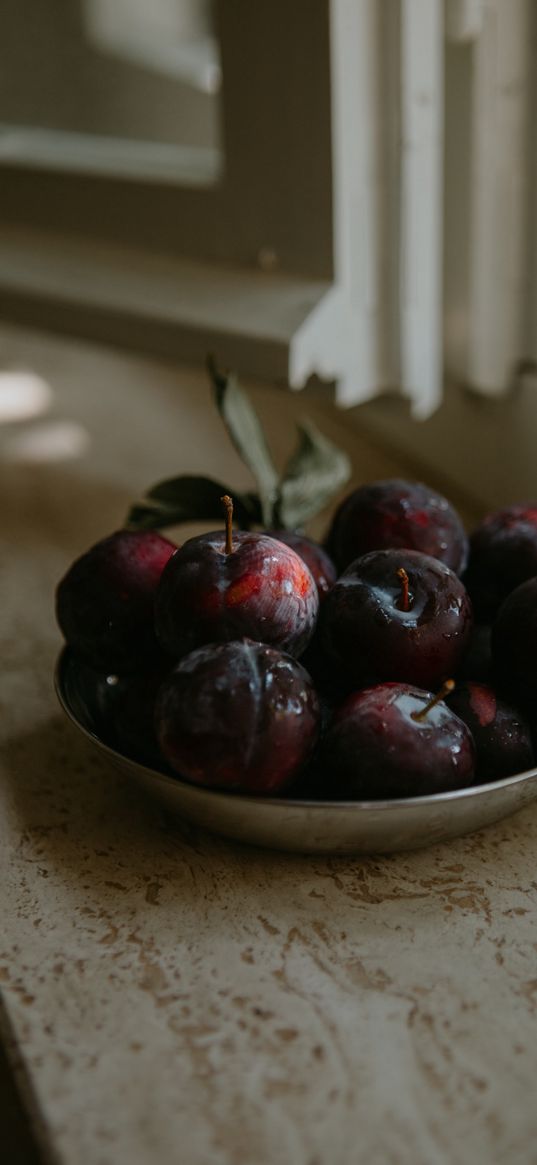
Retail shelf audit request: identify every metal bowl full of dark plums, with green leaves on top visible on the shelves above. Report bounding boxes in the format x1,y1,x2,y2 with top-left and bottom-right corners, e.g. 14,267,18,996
56,366,537,854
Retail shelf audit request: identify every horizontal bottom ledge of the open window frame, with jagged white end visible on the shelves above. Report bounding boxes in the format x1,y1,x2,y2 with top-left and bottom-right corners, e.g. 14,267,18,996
0,230,333,387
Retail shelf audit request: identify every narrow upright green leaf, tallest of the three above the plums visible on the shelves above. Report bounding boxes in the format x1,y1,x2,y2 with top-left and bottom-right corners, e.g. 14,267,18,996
207,356,278,527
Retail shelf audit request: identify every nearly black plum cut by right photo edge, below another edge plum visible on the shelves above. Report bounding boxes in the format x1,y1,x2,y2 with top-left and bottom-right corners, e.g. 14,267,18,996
492,578,537,706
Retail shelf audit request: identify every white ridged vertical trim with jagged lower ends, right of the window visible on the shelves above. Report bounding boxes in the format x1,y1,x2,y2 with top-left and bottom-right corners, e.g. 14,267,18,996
332,0,537,417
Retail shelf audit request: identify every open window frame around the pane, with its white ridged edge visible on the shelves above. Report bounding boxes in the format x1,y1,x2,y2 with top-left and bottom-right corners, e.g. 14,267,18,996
0,0,443,411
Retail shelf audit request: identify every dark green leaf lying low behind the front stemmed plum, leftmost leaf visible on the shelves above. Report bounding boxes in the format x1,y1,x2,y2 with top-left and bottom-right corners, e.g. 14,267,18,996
127,474,259,530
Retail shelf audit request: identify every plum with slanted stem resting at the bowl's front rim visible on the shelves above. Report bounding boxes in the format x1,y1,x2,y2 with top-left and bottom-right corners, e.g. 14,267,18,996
320,684,474,800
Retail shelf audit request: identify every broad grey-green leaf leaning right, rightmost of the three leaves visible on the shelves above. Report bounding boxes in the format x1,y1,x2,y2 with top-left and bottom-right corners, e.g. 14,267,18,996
278,418,351,530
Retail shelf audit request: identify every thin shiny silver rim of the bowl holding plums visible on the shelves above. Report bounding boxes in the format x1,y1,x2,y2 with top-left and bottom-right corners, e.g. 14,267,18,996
54,647,537,813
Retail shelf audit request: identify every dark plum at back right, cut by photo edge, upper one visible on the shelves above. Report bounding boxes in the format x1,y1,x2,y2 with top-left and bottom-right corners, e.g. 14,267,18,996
465,502,537,622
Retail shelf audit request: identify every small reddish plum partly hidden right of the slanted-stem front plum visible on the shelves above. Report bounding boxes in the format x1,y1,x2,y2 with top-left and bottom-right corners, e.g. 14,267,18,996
446,682,535,782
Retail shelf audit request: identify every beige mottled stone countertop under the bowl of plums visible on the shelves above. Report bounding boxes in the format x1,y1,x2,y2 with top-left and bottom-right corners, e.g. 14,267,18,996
0,330,537,1165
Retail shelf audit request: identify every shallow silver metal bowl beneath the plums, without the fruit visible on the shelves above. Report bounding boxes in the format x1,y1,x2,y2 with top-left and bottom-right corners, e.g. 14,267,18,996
55,649,537,854
